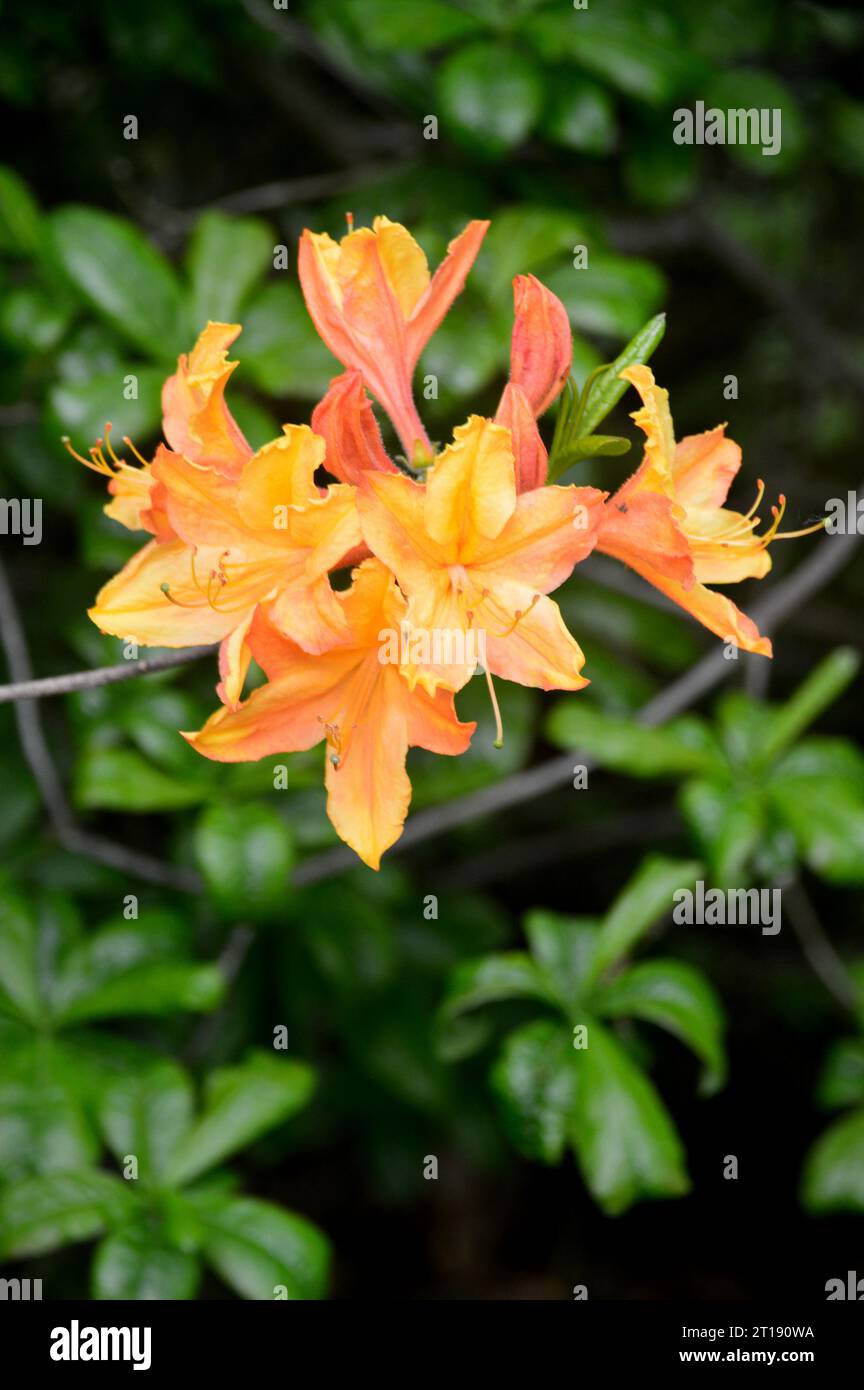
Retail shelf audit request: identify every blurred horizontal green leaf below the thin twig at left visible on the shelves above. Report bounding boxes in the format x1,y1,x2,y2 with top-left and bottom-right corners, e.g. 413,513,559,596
75,750,208,812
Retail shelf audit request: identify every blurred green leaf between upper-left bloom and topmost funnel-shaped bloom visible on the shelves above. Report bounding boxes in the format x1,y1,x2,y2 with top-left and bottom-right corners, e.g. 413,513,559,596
238,284,342,400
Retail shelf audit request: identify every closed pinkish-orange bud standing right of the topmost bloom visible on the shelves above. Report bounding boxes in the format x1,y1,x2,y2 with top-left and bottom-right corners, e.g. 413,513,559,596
510,275,572,414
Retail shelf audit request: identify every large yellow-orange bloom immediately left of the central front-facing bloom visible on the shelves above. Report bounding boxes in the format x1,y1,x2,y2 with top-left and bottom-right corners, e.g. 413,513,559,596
90,425,360,703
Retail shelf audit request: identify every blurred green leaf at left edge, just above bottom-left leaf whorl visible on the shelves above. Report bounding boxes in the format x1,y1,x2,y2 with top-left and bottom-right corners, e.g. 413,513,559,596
0,1078,99,1182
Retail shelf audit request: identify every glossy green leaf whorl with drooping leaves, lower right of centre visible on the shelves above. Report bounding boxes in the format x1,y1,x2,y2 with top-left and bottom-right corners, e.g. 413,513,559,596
439,858,725,1215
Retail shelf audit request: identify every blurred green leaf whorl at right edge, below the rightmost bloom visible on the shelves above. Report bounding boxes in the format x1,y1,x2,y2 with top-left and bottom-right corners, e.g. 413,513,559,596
547,648,864,884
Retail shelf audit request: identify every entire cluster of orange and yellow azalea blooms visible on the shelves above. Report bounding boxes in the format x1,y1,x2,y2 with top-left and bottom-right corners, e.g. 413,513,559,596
74,217,811,869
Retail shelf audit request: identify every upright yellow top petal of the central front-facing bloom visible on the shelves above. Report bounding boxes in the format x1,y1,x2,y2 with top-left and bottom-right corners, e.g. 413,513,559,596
425,416,515,547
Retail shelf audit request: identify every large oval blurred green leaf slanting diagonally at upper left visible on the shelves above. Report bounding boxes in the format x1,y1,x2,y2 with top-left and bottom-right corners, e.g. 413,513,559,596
50,207,188,361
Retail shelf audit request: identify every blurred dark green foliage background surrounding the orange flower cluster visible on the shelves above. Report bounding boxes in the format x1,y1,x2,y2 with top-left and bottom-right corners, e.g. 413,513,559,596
0,0,864,1298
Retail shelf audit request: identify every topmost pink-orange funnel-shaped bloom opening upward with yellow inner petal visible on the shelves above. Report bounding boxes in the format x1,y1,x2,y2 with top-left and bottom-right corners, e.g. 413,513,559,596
299,217,489,460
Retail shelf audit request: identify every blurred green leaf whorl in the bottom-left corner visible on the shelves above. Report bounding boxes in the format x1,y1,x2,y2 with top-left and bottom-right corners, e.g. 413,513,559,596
0,1054,329,1300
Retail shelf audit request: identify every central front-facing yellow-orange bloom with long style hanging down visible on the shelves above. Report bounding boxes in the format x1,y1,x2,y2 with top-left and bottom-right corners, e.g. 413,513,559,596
357,416,604,691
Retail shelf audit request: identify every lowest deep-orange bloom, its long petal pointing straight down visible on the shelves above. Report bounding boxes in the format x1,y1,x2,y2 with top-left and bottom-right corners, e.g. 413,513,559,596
183,560,475,869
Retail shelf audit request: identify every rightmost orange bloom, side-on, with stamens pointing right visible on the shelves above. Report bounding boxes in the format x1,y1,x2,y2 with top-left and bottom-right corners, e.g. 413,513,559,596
597,366,817,656
